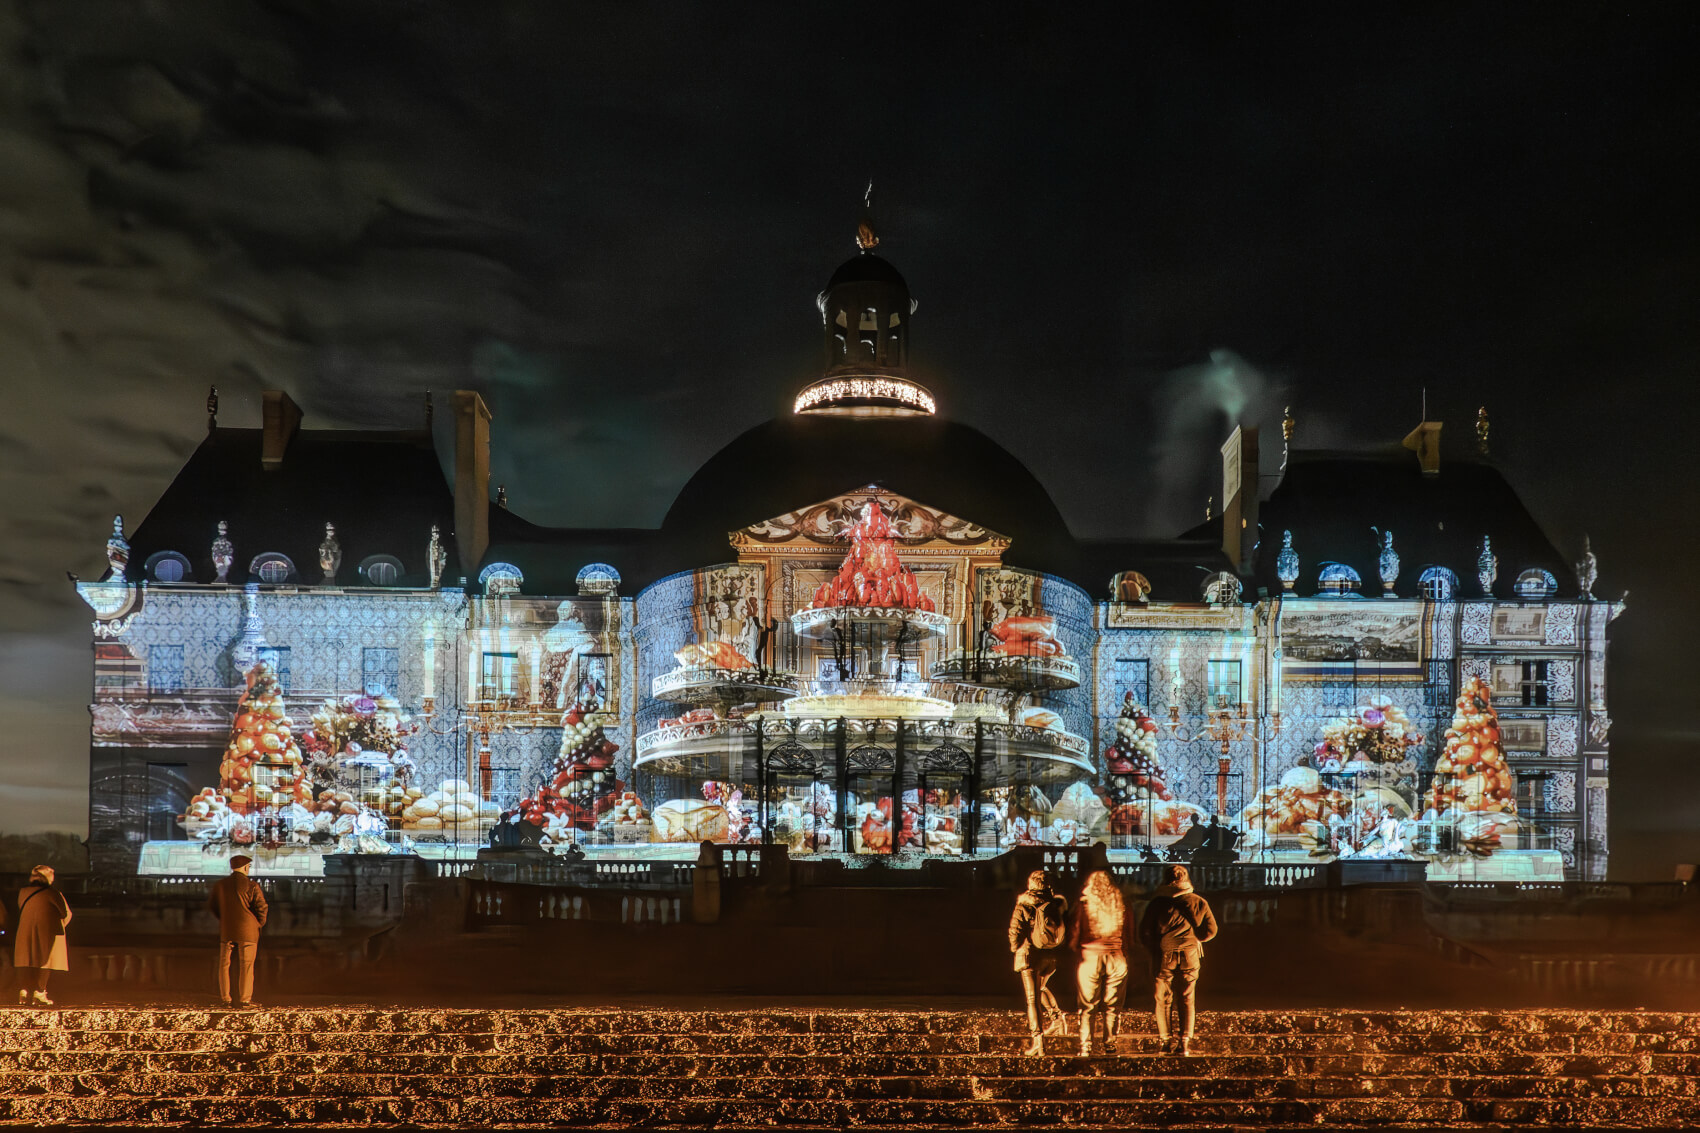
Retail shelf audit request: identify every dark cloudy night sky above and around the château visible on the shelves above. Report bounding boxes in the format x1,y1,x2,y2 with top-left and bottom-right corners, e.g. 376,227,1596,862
0,0,1700,878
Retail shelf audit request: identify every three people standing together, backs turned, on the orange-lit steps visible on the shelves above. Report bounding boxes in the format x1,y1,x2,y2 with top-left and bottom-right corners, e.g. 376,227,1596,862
1010,866,1216,1056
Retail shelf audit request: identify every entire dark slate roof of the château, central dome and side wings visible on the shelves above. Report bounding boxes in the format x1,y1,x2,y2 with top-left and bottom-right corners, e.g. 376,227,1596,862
128,415,1576,602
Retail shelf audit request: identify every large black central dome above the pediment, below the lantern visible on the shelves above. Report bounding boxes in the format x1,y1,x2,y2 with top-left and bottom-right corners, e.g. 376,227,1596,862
661,413,1080,578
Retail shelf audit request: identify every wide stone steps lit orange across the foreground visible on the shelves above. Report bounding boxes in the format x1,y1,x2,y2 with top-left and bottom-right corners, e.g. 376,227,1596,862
0,1007,1700,1130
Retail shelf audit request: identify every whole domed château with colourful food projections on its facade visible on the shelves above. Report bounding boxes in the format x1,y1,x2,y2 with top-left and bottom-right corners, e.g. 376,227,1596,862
78,228,1622,880
